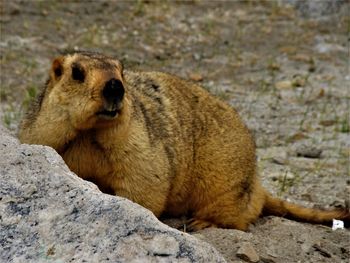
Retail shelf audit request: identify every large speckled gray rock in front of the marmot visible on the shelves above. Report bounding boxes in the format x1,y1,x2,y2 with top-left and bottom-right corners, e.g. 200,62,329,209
0,126,224,262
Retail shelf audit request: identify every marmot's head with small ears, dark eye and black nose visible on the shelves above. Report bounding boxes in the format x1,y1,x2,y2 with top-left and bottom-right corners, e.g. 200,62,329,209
45,52,127,130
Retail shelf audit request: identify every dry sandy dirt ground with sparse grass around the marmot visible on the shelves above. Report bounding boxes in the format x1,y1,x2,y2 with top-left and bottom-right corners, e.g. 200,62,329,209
0,0,350,262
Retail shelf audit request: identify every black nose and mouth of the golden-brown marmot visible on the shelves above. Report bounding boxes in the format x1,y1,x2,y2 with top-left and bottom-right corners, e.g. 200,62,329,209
98,78,125,118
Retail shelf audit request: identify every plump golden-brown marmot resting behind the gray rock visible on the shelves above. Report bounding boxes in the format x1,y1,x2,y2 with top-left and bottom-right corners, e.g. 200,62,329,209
19,52,350,231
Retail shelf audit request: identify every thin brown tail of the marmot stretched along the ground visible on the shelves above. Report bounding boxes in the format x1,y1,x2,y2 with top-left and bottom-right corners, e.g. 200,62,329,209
263,193,350,227
